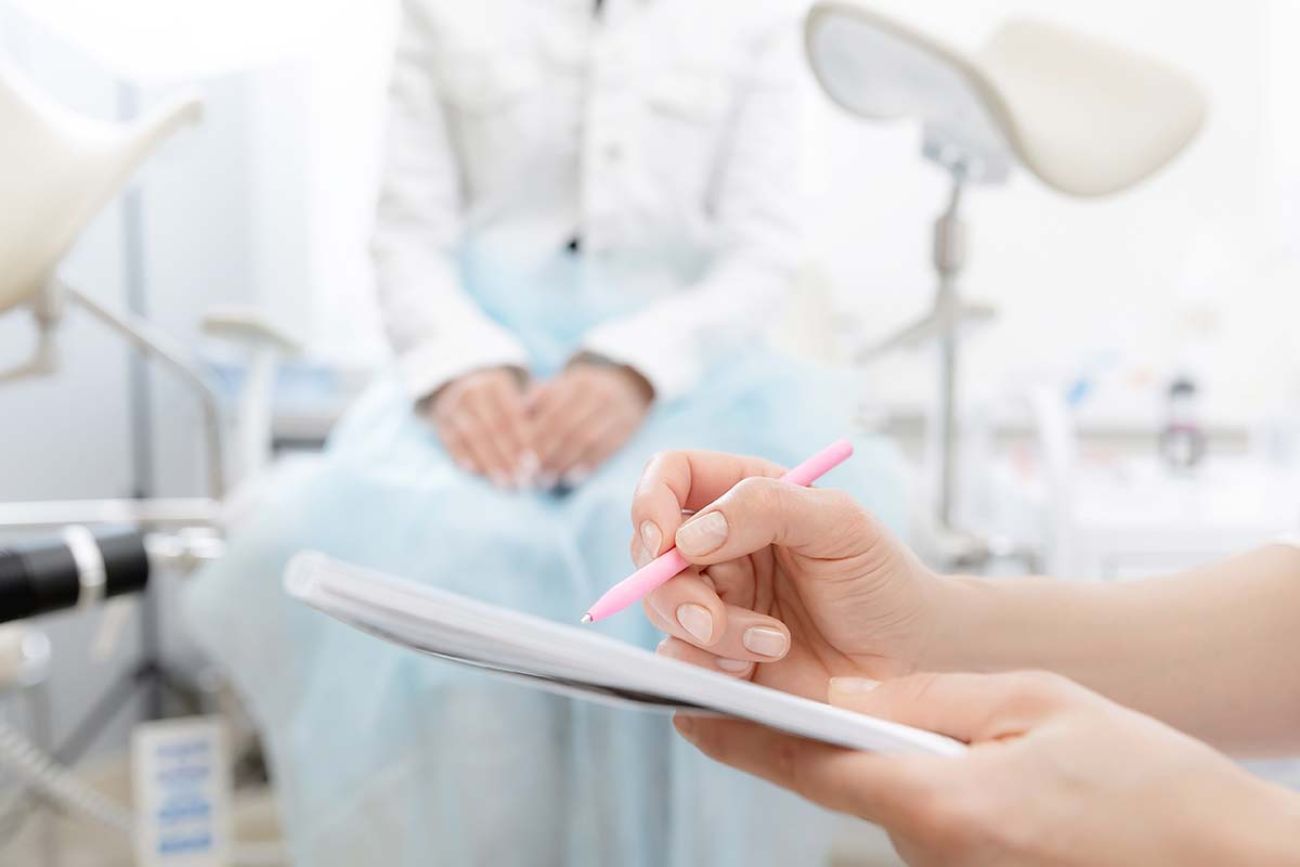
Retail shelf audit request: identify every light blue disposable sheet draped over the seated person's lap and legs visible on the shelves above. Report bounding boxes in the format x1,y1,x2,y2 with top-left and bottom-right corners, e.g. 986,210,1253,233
186,249,904,867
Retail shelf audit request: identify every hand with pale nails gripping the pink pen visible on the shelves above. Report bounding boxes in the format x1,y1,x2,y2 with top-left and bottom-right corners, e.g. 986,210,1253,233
632,451,943,698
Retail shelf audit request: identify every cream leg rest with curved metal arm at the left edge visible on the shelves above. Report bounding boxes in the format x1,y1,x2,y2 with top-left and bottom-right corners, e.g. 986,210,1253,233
0,71,298,509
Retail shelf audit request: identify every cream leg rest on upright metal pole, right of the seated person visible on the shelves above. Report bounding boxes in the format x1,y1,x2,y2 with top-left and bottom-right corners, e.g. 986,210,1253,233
805,0,1205,563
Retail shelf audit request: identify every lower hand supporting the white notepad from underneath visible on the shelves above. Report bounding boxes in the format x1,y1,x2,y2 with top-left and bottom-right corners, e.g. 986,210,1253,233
676,672,1300,867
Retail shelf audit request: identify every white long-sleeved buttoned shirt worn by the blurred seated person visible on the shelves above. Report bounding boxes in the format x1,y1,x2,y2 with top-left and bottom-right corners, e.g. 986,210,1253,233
373,0,806,399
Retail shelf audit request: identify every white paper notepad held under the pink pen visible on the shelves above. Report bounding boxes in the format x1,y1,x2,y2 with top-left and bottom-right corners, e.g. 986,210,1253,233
285,552,966,755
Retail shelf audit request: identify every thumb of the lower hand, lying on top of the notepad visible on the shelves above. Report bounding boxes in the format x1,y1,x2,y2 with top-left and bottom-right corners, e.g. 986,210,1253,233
827,671,1092,744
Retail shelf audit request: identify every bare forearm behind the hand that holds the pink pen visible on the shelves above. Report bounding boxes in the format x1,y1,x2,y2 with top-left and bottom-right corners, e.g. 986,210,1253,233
926,546,1300,753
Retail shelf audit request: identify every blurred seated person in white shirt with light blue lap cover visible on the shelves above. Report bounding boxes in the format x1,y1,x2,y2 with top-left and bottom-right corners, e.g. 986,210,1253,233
190,0,901,866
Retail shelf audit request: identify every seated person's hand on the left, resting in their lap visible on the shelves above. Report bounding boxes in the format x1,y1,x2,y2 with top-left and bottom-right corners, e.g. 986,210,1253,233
428,368,538,489
